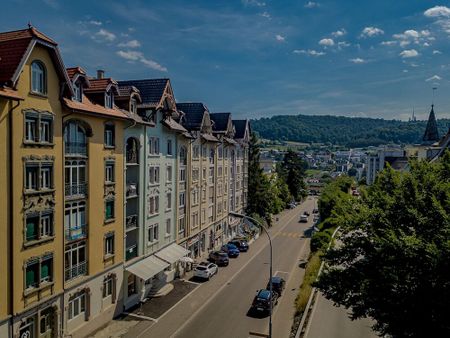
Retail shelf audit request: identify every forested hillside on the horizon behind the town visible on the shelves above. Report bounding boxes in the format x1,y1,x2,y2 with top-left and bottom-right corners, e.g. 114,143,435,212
251,115,450,147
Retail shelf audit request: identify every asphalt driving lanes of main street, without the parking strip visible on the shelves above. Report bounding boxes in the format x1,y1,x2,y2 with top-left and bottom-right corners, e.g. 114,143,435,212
172,198,316,338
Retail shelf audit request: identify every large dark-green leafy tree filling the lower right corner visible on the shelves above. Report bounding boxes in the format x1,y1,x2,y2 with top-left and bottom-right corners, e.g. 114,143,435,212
316,156,450,338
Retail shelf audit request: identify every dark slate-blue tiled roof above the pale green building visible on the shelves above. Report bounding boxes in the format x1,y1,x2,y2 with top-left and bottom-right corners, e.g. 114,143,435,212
119,79,169,108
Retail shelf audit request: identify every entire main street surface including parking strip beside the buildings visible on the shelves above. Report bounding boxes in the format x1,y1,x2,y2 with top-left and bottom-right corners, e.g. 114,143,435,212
126,198,316,338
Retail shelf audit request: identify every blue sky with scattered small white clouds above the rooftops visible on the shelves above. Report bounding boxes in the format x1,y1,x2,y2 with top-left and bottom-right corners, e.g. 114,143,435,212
0,0,450,120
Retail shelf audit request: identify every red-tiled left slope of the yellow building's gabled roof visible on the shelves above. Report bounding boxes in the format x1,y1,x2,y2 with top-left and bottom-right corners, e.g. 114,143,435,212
0,27,57,83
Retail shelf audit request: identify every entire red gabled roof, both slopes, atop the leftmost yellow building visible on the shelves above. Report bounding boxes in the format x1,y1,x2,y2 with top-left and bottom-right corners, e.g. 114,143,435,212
0,26,72,94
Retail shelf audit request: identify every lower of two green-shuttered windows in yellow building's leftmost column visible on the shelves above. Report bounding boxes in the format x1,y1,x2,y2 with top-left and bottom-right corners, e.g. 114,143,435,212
25,254,53,289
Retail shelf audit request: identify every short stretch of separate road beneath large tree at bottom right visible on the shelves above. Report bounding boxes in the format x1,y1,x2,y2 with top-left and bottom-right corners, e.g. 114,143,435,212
304,286,378,338
